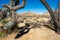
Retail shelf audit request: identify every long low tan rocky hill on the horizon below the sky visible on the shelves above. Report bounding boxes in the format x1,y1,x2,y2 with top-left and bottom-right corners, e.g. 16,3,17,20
18,11,50,18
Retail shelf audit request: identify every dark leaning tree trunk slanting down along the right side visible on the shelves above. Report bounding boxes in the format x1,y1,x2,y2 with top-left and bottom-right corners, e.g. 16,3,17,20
40,0,60,32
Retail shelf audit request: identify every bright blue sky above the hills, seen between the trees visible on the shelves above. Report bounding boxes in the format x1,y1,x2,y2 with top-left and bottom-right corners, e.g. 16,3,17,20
0,0,58,14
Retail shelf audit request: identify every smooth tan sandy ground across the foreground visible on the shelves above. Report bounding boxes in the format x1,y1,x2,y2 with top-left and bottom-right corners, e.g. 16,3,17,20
0,26,60,40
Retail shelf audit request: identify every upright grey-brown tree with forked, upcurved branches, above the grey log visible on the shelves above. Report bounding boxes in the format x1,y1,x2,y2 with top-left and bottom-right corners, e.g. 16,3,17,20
3,0,26,20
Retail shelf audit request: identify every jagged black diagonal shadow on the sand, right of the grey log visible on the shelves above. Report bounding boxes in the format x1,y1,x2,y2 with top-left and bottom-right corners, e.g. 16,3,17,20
15,24,30,39
